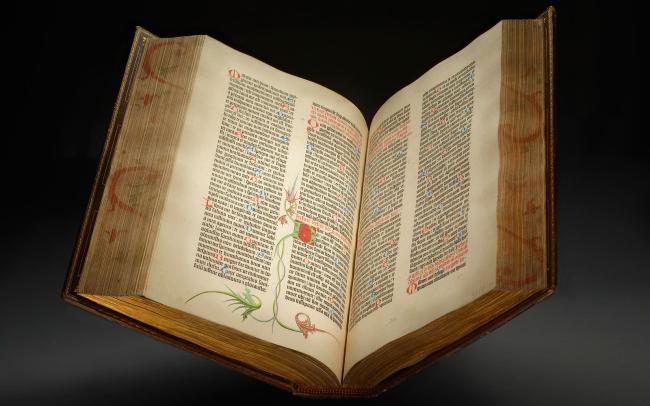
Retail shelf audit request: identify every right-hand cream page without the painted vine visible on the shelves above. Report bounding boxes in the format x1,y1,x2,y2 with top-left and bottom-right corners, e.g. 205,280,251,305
345,20,501,372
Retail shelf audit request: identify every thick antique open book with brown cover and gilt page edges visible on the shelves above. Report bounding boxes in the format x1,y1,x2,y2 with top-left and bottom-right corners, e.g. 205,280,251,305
63,9,555,396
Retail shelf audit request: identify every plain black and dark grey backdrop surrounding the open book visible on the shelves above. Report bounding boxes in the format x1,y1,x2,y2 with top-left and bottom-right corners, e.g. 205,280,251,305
0,1,650,405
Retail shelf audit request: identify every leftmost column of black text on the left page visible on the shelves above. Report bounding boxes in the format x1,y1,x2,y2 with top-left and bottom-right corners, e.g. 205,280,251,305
194,69,295,291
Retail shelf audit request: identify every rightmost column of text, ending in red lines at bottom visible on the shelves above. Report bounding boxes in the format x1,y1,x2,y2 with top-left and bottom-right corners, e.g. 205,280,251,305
407,63,474,294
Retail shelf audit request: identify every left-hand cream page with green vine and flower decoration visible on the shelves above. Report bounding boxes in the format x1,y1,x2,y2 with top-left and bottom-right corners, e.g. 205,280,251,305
145,38,367,379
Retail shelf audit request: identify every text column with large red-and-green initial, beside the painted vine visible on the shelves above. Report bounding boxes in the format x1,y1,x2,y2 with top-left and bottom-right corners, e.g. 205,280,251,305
285,103,361,328
